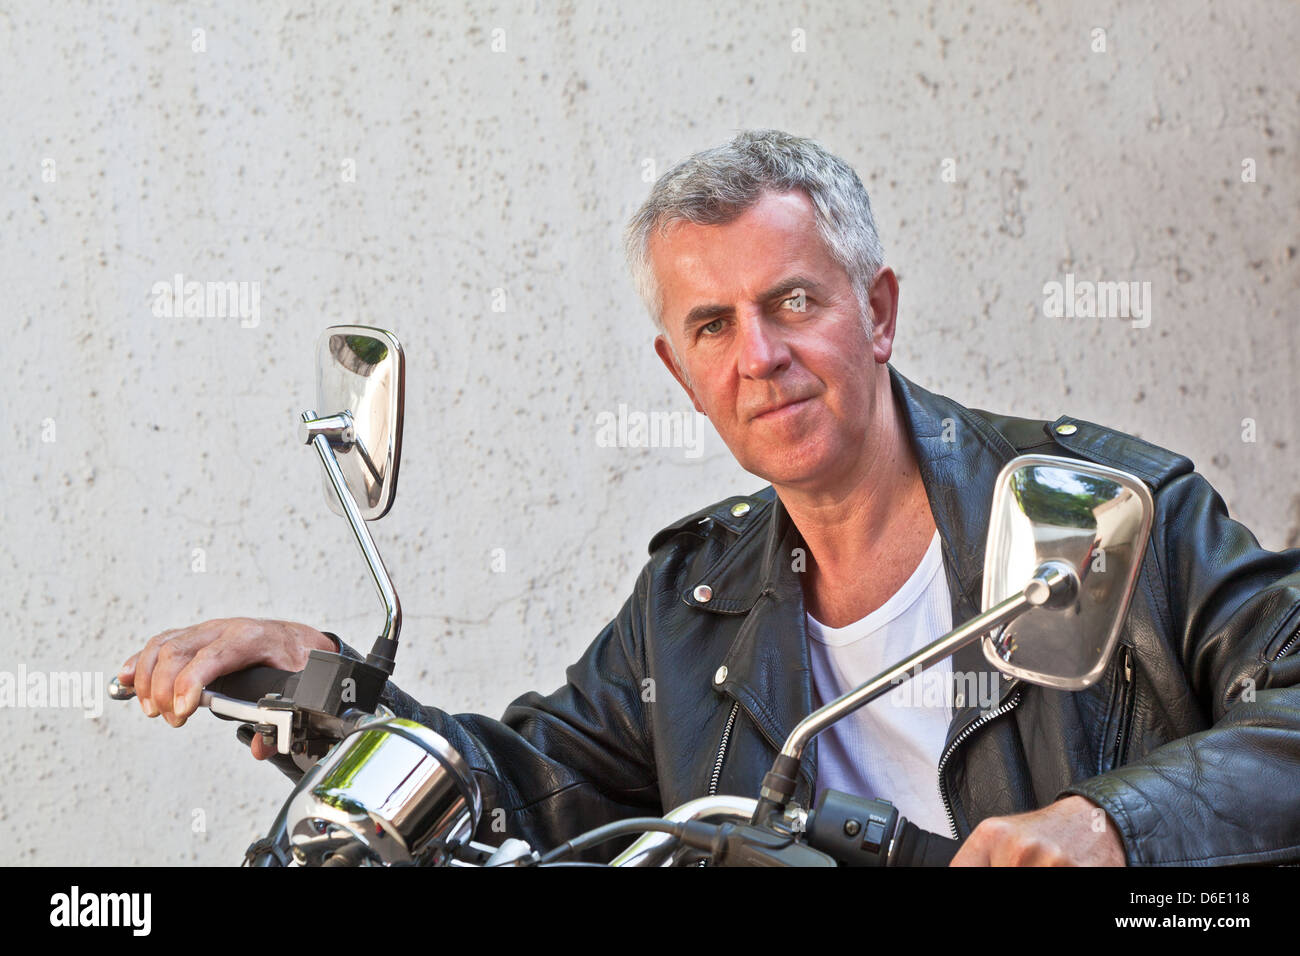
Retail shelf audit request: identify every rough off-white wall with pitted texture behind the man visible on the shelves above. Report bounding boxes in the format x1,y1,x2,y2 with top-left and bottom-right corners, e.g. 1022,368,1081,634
0,0,1300,864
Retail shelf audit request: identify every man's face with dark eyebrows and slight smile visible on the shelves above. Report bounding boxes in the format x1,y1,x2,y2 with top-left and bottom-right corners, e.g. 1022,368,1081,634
650,191,897,490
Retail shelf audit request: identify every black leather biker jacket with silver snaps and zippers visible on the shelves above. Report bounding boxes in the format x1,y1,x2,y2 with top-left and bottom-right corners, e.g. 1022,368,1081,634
345,369,1300,865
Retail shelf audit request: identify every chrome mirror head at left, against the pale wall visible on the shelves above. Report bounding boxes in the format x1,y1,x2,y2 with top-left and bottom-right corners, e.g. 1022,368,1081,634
316,325,406,520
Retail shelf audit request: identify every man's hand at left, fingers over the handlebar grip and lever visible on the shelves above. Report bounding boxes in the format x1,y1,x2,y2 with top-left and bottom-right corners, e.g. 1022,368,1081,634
117,618,334,760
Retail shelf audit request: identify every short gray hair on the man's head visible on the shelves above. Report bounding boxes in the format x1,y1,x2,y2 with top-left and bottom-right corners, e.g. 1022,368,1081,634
624,130,884,341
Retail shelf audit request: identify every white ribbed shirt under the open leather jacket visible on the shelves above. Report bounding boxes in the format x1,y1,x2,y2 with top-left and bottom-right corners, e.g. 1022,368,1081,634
807,531,953,836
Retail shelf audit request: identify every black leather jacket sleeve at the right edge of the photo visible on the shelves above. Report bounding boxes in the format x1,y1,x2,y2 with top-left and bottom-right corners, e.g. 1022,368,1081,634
1062,472,1300,866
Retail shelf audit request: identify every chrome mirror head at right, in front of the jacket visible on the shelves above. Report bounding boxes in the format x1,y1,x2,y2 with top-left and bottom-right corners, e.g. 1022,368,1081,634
983,455,1154,691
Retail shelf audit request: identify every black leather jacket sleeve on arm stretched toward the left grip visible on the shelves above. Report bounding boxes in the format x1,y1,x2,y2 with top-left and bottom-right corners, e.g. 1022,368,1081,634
325,566,662,860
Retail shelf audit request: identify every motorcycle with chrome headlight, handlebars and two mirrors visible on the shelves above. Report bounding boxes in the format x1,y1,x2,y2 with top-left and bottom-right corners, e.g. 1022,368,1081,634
109,325,1153,866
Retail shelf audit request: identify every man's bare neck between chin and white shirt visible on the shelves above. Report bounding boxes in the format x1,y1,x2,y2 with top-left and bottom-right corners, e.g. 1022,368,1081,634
776,376,935,627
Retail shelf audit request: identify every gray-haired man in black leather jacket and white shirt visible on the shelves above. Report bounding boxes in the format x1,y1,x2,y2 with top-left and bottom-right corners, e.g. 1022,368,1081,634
121,130,1300,865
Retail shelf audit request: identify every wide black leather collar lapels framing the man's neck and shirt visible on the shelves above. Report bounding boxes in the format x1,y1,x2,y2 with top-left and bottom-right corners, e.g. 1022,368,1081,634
702,365,1017,788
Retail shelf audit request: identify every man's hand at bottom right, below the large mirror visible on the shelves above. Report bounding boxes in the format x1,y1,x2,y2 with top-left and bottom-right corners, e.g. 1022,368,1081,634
952,796,1127,866
